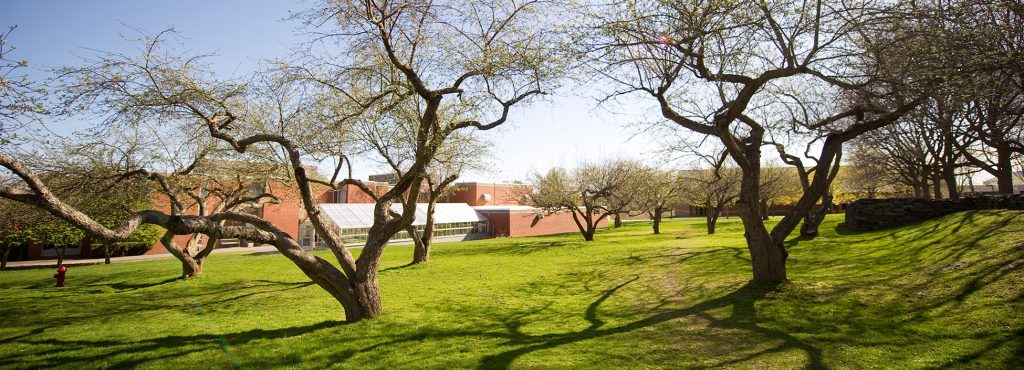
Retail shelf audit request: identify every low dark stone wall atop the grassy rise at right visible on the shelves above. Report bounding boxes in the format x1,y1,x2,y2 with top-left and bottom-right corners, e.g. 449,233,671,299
846,194,1024,231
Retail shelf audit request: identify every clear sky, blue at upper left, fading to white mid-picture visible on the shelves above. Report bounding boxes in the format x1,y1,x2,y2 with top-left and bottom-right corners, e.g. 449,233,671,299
0,0,656,181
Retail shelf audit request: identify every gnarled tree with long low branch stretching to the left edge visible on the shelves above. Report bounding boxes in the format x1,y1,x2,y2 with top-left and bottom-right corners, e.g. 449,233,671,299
0,0,561,321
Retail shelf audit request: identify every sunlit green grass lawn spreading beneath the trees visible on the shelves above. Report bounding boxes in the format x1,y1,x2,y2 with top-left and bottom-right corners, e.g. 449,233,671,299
0,211,1024,369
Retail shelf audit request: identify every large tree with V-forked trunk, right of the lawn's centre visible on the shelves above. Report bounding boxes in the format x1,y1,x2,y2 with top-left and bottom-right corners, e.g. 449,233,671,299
585,0,924,284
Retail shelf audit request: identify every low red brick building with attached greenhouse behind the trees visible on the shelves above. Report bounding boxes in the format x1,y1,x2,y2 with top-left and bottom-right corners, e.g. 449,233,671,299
15,175,607,259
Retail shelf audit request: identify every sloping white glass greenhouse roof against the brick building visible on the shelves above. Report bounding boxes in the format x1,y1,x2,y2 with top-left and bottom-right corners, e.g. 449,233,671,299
319,203,487,229
